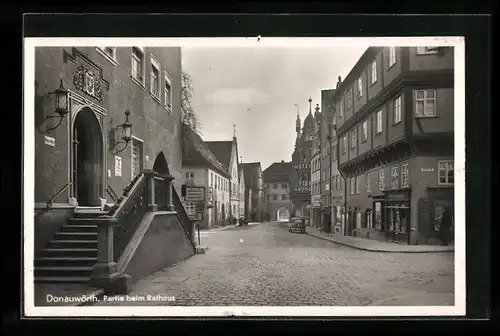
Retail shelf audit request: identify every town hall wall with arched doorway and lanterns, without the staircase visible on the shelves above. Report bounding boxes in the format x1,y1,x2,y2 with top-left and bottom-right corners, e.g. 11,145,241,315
34,46,183,250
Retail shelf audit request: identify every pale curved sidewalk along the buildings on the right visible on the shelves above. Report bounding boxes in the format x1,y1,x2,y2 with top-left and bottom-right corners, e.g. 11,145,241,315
306,227,455,253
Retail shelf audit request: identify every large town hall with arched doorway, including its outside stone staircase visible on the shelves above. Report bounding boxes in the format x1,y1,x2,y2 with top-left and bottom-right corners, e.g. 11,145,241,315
33,46,195,292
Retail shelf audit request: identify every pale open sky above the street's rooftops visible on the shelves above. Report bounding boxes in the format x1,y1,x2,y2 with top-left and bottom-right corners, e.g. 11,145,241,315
182,45,368,170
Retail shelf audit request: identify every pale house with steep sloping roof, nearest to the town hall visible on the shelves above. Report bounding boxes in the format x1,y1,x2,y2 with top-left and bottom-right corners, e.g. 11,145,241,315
182,124,231,229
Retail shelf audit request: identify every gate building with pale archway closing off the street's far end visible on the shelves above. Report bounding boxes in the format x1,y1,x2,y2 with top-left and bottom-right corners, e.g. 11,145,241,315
262,160,293,221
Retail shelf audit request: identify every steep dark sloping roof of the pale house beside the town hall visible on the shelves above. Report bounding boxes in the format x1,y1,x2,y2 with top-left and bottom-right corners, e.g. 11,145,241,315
182,124,229,177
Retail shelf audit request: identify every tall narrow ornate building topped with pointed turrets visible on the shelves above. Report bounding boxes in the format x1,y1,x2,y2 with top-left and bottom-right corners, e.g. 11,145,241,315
290,98,315,218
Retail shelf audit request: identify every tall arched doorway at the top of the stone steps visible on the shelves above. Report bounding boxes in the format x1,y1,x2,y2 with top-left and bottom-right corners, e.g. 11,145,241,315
72,108,104,206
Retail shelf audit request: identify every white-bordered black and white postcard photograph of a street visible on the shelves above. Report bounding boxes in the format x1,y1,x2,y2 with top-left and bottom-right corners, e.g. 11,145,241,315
24,36,465,316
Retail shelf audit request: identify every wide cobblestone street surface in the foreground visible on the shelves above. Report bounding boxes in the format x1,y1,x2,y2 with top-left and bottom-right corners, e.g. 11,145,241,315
95,223,454,306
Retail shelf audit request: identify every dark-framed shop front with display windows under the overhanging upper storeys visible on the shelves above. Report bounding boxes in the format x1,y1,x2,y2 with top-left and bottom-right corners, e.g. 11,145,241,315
367,189,412,244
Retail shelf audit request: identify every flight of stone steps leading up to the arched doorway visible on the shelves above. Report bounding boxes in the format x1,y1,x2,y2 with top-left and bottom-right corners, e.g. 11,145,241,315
34,207,106,283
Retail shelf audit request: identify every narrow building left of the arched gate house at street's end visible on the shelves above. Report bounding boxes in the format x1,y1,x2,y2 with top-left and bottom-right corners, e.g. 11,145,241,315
241,162,265,222
